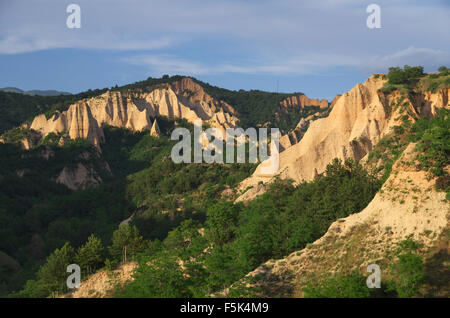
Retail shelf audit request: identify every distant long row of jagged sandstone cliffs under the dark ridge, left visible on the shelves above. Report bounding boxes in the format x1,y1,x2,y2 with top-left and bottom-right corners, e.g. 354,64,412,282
30,78,238,146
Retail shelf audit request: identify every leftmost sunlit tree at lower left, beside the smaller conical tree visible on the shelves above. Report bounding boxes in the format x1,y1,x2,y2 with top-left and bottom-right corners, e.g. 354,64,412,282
38,242,75,296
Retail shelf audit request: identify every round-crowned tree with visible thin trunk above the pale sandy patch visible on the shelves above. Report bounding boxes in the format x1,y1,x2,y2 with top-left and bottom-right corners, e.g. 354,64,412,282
109,224,144,262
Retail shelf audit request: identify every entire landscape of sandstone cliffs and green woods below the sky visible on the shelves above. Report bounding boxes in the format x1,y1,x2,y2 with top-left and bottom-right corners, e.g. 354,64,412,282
0,68,450,297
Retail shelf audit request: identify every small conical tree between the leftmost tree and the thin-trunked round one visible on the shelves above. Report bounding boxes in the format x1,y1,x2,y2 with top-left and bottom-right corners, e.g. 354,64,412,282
75,234,104,274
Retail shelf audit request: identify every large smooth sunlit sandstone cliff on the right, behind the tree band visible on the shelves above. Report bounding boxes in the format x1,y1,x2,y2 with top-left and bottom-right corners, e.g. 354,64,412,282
238,76,448,200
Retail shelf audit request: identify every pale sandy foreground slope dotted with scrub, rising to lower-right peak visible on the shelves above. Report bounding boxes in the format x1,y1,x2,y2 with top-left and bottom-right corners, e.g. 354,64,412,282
230,144,450,297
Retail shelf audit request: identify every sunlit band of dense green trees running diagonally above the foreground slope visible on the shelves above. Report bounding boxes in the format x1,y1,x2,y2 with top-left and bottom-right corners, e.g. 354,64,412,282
108,160,380,297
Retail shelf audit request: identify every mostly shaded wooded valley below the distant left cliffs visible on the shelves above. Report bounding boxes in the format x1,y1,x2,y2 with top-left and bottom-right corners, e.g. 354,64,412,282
0,117,255,295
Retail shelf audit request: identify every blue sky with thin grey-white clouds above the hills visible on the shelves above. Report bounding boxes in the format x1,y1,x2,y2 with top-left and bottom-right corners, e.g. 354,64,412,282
0,0,450,100
